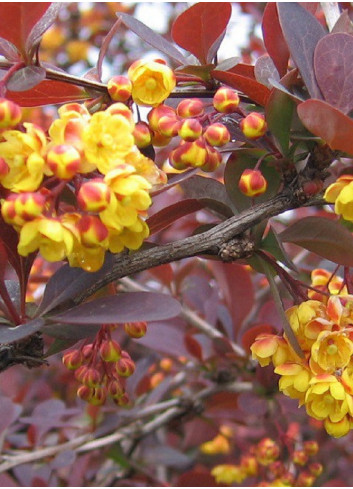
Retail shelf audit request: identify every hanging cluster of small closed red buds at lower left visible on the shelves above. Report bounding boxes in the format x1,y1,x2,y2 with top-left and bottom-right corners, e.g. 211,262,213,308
63,322,146,406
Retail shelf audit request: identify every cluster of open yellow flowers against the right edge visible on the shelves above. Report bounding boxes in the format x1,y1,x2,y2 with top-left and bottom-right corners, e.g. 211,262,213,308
251,270,353,437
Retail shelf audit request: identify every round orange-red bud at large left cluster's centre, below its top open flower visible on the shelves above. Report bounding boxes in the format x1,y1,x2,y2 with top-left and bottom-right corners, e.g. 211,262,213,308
77,178,111,212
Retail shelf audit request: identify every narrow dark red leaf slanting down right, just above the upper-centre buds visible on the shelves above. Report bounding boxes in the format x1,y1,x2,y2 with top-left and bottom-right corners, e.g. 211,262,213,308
211,67,270,106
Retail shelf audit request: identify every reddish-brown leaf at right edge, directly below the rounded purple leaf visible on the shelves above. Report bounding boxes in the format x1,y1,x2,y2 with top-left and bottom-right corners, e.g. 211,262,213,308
297,100,353,154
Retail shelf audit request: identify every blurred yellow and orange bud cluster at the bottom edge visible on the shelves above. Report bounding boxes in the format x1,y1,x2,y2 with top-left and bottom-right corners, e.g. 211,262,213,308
211,432,323,487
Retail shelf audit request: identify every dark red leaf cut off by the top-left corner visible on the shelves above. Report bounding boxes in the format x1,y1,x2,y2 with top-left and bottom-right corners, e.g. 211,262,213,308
0,2,50,57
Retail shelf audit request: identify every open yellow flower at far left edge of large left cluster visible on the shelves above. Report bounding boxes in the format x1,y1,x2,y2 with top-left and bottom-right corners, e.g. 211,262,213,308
0,122,47,192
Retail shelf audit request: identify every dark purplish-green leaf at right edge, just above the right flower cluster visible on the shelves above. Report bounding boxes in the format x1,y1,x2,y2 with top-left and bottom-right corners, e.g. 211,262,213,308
279,217,353,267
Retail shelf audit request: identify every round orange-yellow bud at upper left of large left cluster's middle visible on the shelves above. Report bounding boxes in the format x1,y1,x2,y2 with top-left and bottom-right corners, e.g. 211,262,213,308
47,144,81,180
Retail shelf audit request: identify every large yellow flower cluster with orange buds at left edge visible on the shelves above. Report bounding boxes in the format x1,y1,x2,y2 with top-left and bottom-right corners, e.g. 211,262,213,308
0,103,165,271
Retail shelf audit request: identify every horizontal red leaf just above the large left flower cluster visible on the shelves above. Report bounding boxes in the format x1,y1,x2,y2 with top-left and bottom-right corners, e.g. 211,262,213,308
6,80,89,107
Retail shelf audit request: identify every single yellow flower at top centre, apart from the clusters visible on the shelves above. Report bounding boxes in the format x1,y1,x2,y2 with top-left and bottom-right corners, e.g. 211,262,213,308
128,60,176,107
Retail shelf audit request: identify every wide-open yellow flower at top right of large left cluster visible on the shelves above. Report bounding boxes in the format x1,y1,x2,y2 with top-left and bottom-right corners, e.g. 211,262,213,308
82,112,135,175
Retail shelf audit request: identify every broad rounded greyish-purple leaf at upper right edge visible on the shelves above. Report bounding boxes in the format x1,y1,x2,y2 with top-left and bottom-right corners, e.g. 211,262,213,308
314,32,353,114
